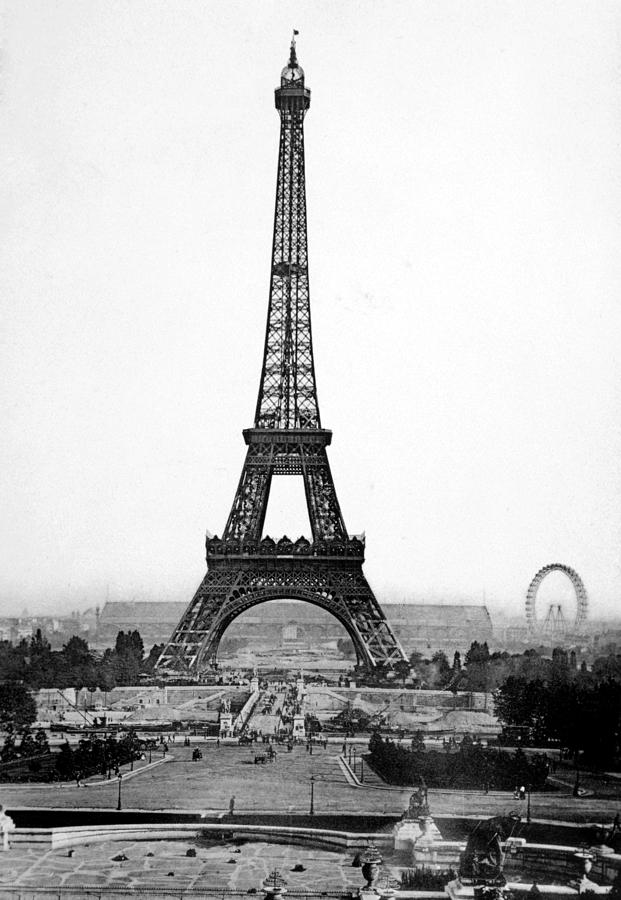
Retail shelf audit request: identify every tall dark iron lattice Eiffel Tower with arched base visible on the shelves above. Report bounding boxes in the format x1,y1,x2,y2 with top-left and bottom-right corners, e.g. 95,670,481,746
157,35,405,676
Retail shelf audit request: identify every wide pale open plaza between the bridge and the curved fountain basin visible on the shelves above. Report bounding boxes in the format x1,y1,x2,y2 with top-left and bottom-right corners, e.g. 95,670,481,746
0,739,621,823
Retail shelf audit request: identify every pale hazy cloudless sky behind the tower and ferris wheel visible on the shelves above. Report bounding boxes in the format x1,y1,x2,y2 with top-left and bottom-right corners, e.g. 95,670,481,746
0,0,621,616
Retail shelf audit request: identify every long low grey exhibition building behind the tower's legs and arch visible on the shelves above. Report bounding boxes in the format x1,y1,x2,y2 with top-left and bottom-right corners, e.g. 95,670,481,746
92,601,492,654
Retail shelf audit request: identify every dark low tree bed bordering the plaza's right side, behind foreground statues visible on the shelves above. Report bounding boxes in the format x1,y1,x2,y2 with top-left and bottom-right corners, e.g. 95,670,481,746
369,733,549,791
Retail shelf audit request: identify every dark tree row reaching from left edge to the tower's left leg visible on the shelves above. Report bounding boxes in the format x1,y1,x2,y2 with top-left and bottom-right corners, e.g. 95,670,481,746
0,629,162,691
